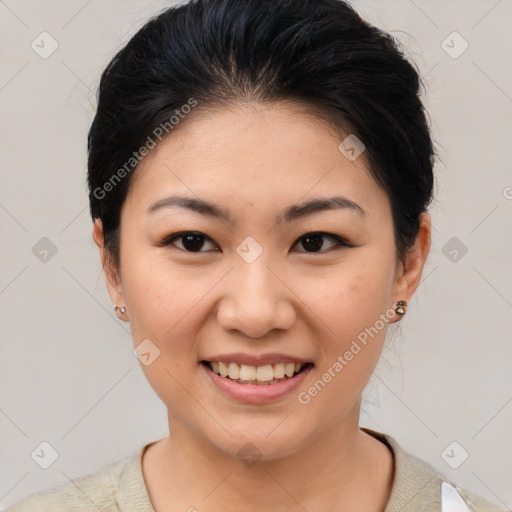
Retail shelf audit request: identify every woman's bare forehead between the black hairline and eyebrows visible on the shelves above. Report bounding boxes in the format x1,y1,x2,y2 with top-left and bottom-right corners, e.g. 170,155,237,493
126,103,387,219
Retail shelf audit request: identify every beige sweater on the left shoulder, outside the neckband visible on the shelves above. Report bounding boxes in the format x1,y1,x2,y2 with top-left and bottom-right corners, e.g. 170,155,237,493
6,458,132,512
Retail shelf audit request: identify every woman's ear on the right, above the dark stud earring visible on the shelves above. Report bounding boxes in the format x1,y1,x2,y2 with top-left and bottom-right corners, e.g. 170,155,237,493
393,212,432,302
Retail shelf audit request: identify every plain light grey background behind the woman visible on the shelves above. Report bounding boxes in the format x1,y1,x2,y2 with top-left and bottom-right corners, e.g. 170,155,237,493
0,0,512,510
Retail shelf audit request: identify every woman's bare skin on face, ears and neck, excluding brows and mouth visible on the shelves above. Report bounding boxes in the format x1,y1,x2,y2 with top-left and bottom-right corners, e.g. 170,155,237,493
93,103,430,512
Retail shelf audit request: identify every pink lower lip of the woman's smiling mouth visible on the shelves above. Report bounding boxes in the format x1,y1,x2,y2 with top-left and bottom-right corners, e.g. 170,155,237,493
199,363,313,404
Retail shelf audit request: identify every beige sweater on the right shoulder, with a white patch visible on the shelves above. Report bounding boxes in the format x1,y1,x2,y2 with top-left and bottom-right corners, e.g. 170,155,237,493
362,428,512,512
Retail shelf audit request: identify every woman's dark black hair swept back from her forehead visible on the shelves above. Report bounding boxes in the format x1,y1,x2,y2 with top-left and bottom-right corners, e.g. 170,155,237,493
88,0,435,272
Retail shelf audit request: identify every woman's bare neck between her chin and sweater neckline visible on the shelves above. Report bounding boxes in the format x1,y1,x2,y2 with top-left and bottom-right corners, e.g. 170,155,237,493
143,408,393,512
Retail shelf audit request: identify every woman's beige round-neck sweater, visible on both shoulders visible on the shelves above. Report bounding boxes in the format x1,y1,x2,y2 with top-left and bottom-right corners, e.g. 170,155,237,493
6,427,512,512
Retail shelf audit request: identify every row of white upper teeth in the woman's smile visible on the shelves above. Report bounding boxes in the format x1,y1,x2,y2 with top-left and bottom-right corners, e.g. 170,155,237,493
209,362,304,384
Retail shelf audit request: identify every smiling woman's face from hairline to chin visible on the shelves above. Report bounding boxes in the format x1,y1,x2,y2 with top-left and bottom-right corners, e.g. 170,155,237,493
95,104,428,459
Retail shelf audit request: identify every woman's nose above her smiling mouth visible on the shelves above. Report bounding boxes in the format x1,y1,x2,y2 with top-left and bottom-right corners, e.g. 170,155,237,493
217,255,296,338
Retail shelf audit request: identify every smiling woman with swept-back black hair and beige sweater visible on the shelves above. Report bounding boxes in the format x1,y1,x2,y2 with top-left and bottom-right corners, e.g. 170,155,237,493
10,0,506,512
